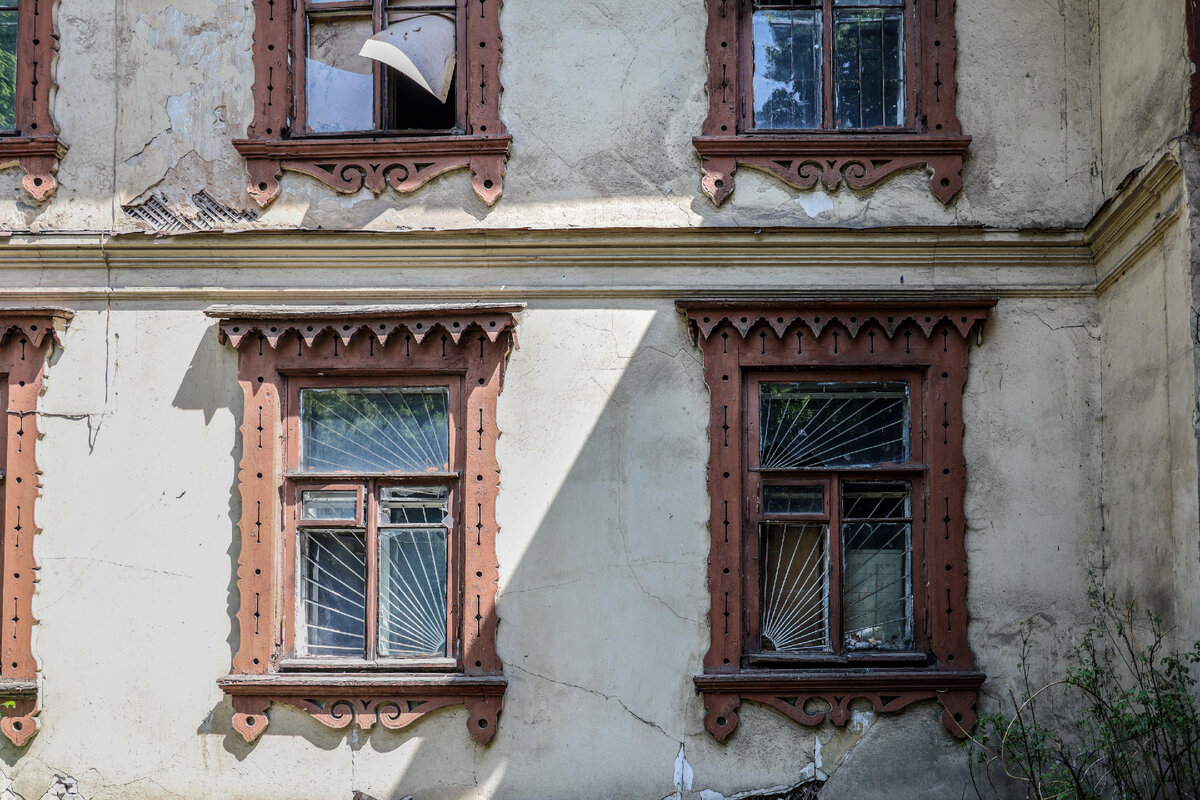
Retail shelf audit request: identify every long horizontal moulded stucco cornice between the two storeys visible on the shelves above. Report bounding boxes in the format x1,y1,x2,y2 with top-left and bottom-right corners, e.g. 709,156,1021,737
0,149,1187,303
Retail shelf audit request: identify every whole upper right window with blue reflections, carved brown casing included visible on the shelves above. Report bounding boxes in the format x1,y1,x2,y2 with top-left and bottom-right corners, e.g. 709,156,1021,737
694,0,971,205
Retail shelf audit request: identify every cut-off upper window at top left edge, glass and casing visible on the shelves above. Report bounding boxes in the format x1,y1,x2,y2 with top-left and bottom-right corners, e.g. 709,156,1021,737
0,0,66,201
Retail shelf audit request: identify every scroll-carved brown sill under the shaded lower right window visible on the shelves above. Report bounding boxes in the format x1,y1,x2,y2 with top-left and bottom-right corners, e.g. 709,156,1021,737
692,667,986,741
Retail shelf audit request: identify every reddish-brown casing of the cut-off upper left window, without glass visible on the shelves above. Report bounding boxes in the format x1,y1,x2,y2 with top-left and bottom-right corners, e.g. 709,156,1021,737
0,0,66,203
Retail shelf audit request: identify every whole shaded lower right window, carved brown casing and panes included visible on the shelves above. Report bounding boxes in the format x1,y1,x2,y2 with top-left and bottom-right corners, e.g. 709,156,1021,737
679,299,995,740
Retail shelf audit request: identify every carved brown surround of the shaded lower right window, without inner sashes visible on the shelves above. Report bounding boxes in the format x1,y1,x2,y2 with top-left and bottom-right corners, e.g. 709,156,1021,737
678,297,995,741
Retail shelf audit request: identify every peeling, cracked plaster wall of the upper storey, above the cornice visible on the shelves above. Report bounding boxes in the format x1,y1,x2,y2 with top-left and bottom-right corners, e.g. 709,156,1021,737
0,0,1123,230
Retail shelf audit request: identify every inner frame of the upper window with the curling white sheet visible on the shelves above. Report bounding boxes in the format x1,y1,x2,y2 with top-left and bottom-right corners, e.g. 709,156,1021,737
293,0,467,137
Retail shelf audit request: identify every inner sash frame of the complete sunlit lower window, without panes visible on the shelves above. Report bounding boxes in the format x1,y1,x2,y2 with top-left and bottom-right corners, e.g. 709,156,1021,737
280,374,466,672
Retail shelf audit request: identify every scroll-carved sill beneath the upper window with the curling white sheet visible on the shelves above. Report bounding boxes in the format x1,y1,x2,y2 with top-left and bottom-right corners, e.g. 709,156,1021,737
233,133,512,207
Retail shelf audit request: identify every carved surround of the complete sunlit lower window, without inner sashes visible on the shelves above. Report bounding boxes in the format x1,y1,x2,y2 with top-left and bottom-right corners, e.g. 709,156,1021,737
209,305,521,744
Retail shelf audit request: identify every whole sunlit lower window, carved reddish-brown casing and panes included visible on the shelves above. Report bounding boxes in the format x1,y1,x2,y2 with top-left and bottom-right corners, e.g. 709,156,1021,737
210,306,520,744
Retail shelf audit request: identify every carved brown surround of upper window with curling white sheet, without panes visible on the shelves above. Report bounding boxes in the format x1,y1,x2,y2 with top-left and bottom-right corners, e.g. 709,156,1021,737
233,0,512,207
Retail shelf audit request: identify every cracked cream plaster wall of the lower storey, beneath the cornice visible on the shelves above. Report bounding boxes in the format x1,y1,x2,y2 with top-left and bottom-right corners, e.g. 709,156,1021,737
0,296,1099,800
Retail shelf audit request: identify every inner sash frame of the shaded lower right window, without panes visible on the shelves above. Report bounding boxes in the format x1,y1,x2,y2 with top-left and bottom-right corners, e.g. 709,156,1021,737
743,369,929,667
